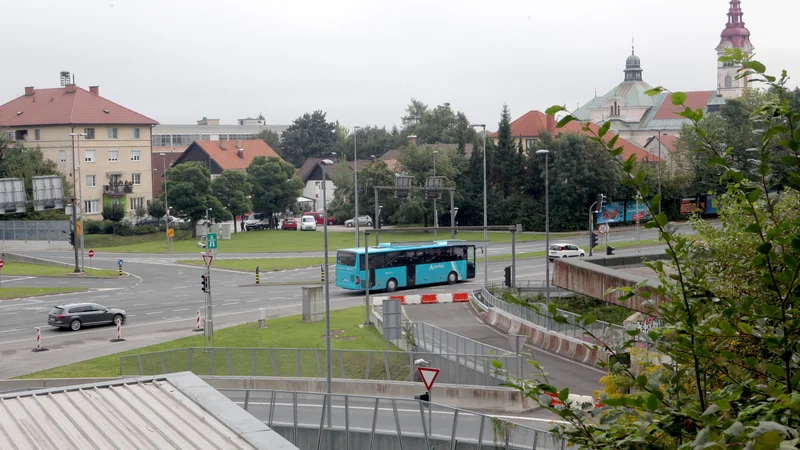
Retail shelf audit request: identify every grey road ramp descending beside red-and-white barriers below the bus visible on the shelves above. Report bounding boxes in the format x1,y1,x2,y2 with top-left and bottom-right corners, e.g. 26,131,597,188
404,303,605,395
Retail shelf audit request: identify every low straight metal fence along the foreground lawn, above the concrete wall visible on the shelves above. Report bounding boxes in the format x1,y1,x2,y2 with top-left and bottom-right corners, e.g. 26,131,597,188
119,347,517,386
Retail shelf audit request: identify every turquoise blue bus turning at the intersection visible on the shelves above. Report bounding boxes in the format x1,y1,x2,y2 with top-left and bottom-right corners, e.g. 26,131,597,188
336,240,475,292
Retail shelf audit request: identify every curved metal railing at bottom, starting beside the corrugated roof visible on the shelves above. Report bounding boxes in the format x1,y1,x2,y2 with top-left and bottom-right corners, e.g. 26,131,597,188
219,389,566,450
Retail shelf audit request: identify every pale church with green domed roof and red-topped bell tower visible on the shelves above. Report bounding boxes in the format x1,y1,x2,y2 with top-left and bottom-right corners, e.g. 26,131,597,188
572,0,754,145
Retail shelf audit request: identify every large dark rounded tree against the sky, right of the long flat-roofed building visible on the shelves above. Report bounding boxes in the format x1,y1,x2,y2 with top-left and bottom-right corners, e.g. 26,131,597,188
280,111,336,166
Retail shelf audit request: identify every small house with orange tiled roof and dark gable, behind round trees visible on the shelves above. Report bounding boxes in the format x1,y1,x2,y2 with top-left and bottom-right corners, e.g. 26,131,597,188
169,139,283,179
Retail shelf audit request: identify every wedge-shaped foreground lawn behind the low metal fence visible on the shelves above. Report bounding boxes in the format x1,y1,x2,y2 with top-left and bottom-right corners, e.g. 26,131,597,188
21,306,408,379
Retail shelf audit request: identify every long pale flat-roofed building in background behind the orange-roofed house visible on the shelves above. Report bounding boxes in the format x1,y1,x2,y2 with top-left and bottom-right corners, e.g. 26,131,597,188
153,117,289,153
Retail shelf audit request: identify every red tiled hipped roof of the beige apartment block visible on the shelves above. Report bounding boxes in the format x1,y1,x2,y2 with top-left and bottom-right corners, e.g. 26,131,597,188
0,86,158,127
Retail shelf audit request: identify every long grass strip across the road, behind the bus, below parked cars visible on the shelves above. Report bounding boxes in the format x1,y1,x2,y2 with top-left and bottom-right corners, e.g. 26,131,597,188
86,230,566,253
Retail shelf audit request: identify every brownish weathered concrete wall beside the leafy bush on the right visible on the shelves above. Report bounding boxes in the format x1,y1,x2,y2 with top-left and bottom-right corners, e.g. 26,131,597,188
553,257,664,315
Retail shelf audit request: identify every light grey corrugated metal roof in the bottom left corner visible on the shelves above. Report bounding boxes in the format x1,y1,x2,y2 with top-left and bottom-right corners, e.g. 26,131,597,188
0,373,296,450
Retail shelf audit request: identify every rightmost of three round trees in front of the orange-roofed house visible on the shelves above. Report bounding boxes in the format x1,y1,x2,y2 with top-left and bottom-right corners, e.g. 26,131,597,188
247,156,303,221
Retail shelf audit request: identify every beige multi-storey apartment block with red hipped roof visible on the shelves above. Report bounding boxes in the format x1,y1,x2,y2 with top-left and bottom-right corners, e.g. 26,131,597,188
0,81,158,220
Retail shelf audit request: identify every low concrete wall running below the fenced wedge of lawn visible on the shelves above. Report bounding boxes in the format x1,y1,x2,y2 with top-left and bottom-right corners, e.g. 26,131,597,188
0,377,538,414
